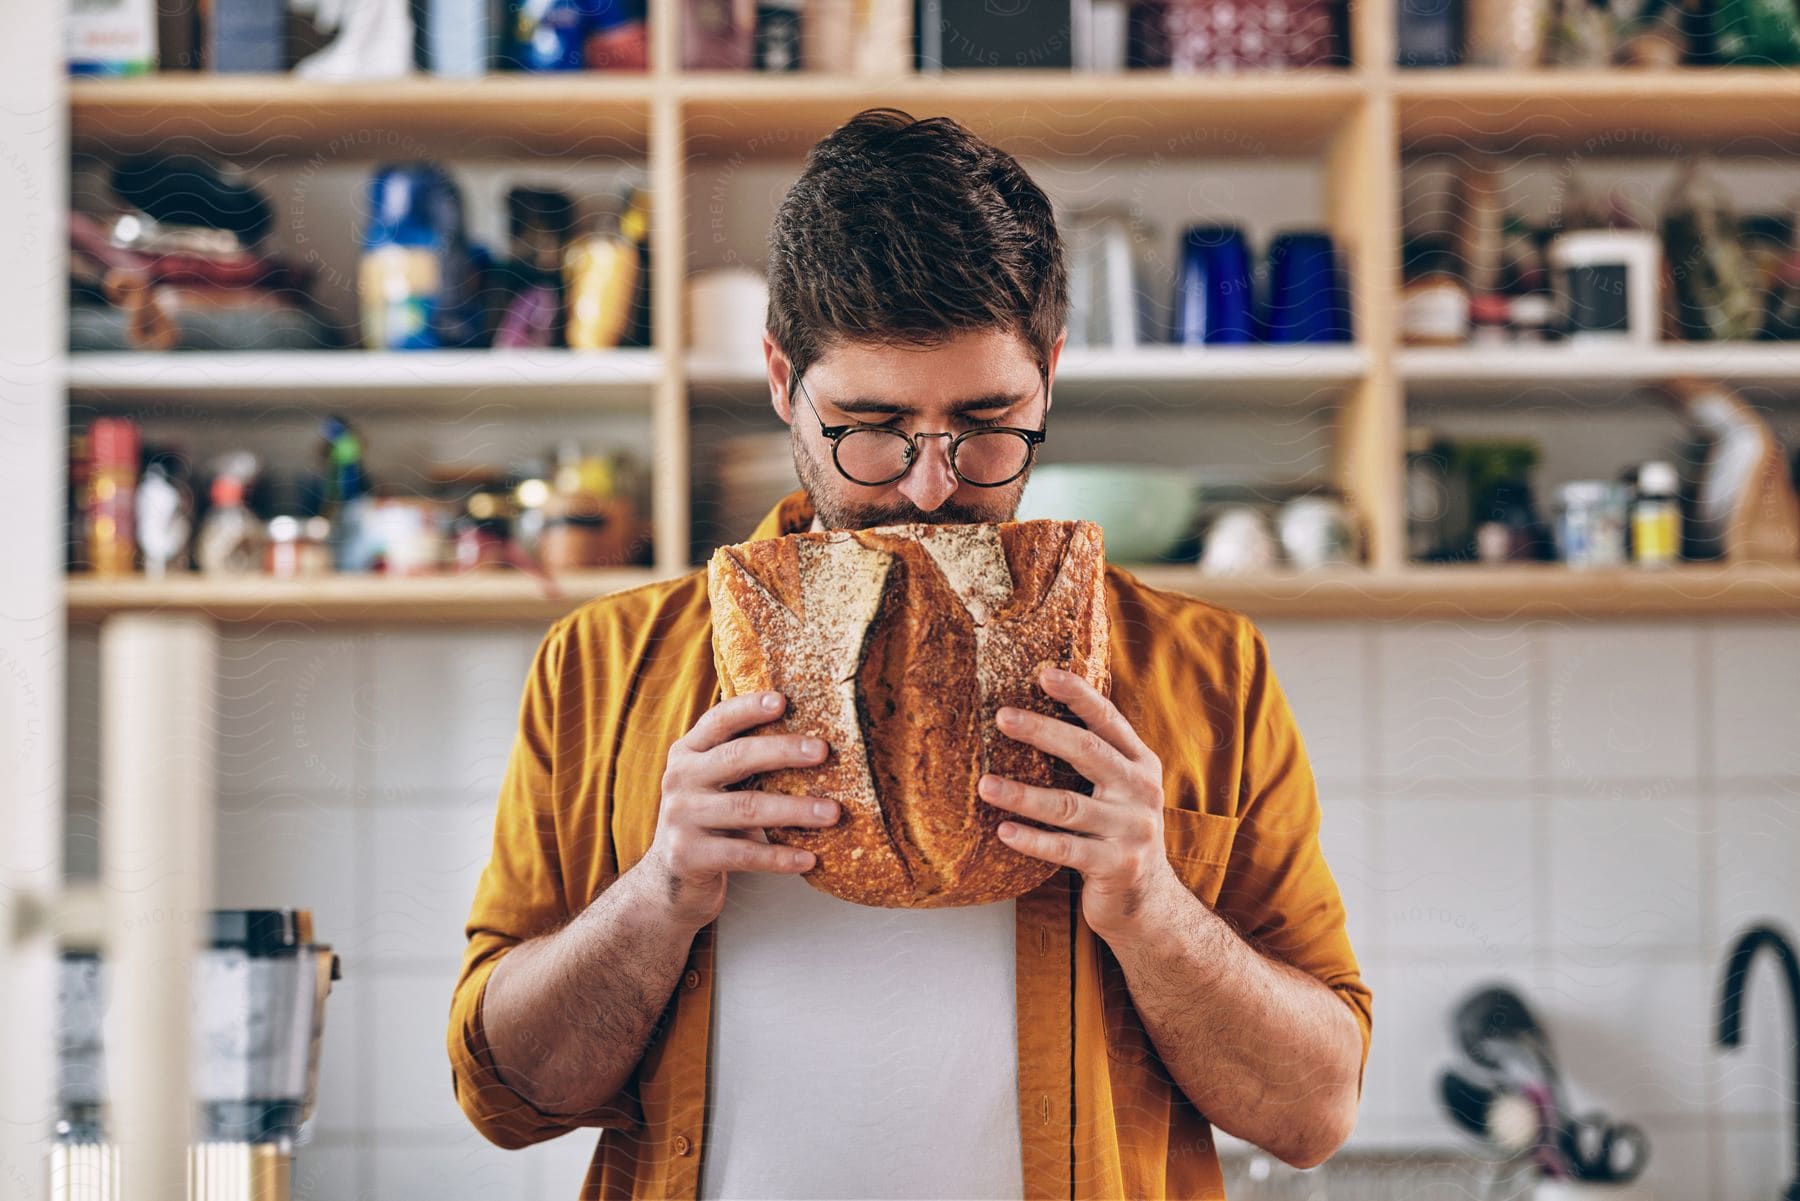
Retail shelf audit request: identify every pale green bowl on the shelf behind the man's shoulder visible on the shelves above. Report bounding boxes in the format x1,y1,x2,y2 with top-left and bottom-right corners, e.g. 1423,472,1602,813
1019,463,1201,564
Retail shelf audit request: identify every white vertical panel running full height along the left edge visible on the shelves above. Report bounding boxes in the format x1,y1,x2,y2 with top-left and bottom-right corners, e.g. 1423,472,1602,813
0,4,68,1201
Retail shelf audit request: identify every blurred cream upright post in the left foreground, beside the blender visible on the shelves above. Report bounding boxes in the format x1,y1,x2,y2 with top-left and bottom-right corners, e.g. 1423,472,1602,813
101,614,218,1201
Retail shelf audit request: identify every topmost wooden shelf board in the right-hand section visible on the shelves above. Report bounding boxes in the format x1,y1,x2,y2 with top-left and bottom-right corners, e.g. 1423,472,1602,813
1393,67,1800,158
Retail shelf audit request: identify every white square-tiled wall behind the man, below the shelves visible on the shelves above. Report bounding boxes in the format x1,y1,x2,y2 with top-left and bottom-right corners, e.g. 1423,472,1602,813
68,621,1800,1201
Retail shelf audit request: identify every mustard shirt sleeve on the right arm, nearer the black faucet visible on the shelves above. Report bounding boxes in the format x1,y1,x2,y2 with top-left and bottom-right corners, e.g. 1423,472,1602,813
1217,621,1373,1087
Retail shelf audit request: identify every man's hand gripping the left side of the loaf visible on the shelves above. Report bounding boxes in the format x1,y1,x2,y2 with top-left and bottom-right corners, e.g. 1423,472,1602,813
639,691,839,931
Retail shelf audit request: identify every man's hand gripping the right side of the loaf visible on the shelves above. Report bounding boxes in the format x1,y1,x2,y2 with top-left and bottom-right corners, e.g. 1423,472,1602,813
979,668,1186,945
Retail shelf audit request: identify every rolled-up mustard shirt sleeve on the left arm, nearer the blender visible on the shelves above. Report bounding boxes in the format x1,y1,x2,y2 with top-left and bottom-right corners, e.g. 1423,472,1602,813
448,623,639,1149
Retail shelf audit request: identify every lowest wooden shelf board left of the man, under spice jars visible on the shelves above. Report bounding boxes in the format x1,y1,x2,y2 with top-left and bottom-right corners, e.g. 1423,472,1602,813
67,567,673,625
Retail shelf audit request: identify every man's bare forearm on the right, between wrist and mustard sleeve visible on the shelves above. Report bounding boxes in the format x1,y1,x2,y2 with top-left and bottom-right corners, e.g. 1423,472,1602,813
1112,886,1363,1167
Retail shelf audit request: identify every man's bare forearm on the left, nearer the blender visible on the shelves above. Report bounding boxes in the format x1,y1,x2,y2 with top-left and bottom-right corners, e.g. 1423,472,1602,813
482,871,695,1115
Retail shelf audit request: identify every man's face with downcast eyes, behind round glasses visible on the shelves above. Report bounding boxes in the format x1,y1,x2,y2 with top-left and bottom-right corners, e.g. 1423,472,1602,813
763,330,1064,529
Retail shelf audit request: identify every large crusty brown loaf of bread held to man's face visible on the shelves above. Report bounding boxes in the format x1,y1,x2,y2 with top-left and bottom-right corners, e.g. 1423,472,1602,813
707,520,1111,908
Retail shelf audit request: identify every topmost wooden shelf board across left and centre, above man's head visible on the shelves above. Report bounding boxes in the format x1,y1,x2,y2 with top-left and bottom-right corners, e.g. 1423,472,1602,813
68,70,1363,160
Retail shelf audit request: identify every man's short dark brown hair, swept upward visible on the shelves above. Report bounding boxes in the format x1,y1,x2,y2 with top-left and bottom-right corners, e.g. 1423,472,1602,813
769,108,1069,383
